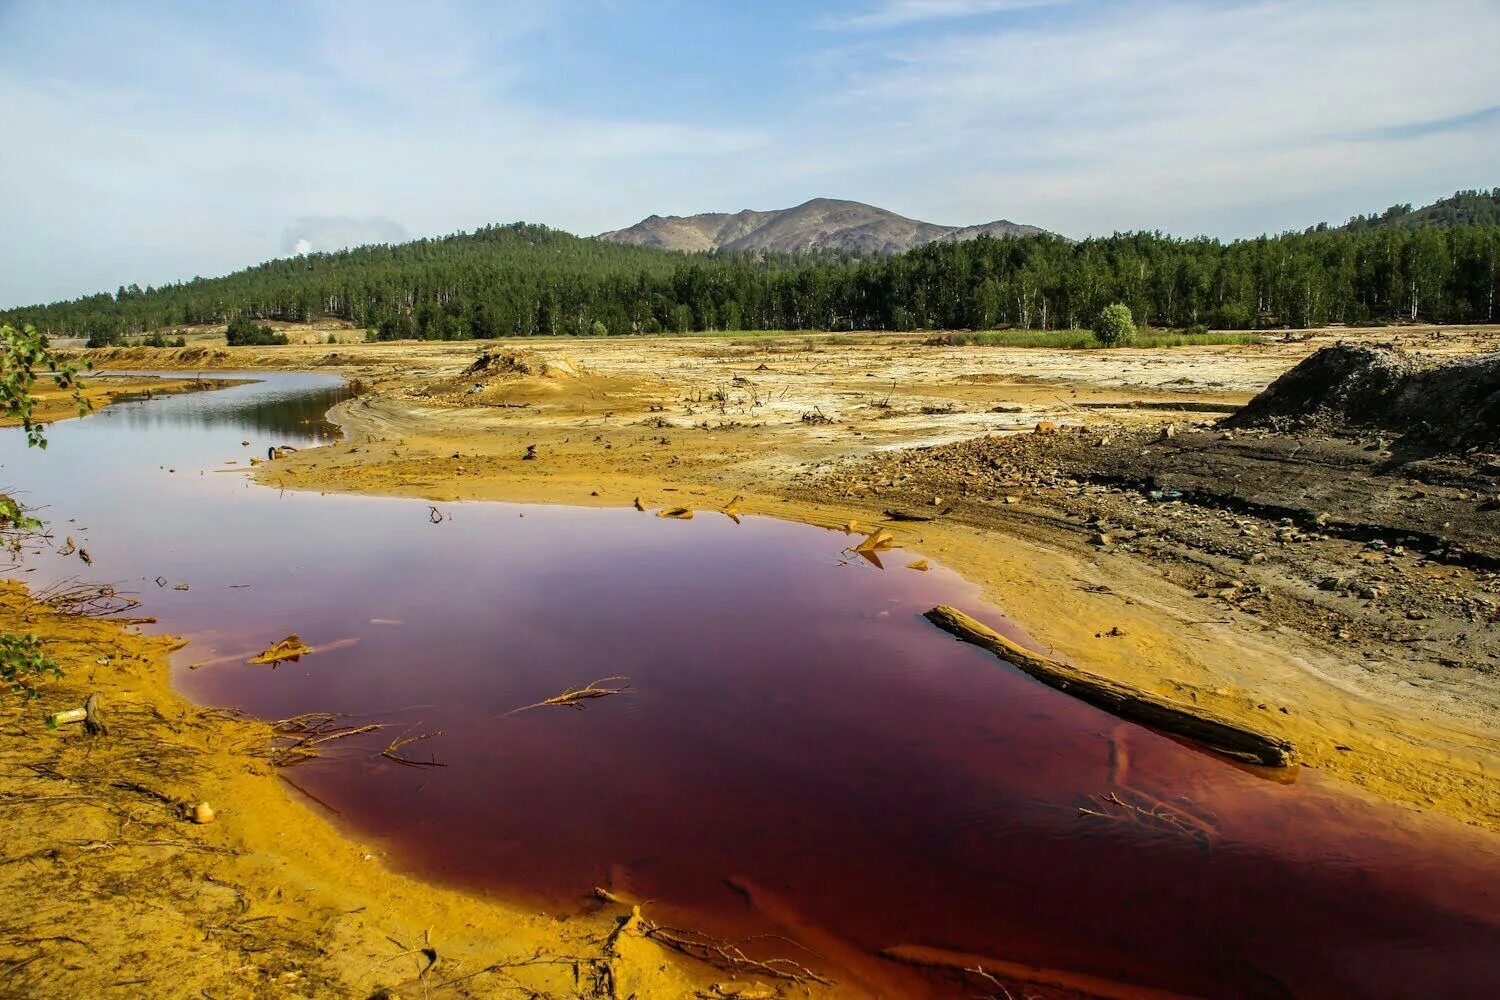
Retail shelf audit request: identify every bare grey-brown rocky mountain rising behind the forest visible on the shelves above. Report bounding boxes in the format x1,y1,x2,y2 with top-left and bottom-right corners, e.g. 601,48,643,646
599,198,1044,253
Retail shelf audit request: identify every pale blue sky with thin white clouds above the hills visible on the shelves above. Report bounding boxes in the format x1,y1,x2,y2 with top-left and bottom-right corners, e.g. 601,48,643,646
0,0,1500,307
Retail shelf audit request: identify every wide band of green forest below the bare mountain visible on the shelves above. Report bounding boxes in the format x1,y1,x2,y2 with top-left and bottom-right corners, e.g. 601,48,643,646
11,190,1500,346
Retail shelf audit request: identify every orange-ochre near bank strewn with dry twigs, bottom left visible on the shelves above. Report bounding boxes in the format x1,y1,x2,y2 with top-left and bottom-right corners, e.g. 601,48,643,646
0,582,708,997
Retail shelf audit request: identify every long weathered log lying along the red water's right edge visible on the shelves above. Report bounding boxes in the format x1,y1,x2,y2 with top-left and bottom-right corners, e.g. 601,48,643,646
924,604,1296,768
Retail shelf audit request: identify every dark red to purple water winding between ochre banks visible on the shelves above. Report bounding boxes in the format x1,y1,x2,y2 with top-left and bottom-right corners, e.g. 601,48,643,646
0,376,1500,997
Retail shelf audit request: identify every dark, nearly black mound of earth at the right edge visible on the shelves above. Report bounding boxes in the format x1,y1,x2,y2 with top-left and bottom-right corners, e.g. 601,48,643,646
1224,345,1500,450
